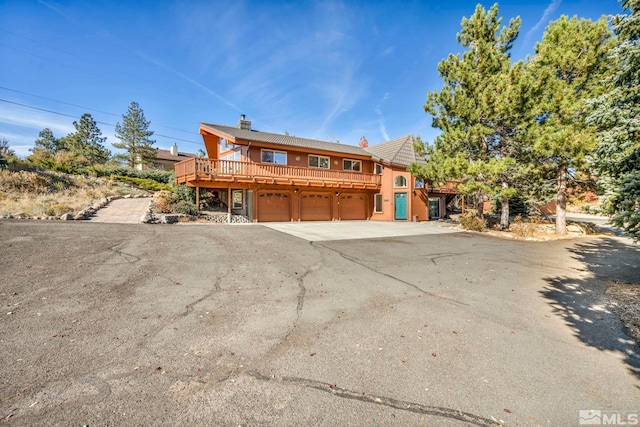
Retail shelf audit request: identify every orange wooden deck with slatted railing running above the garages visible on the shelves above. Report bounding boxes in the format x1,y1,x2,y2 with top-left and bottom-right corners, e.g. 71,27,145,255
175,157,381,187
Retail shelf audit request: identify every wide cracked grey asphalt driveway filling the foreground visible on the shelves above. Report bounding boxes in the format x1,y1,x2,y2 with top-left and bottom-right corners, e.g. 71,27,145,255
0,221,640,426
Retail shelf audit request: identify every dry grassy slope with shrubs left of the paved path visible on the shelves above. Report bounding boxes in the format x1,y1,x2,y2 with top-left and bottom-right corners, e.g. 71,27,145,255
0,170,146,218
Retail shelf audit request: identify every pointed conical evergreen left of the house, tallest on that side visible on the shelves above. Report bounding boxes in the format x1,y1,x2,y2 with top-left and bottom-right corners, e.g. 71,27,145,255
113,101,157,167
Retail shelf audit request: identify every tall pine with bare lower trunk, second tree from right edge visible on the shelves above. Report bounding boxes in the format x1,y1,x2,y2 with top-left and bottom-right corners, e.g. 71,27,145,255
529,16,611,235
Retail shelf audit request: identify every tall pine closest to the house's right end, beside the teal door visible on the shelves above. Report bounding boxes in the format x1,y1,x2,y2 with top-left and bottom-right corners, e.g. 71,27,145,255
409,4,530,228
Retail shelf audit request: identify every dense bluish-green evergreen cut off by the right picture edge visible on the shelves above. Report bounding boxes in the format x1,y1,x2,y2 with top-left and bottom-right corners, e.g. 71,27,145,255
588,0,640,240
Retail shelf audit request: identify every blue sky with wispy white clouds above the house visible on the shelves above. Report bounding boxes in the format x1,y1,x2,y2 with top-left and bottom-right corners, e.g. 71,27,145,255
0,0,622,156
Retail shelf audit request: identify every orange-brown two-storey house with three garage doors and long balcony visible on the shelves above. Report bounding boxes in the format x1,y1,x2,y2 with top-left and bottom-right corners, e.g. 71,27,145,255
175,115,457,222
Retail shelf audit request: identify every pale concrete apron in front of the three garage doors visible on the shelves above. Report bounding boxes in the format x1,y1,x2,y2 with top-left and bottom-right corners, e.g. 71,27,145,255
260,221,460,242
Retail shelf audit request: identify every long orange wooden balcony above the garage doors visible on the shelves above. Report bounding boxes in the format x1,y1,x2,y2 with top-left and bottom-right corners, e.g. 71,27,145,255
175,157,381,190
